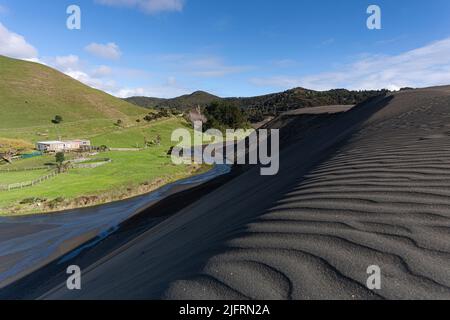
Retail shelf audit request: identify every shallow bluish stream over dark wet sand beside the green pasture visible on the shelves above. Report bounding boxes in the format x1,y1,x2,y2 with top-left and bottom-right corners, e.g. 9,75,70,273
0,166,229,288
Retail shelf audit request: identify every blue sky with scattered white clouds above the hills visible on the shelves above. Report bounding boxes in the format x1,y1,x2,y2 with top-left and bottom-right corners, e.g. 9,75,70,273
0,0,450,97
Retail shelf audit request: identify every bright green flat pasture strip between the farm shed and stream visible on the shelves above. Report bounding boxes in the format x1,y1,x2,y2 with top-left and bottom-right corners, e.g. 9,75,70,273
0,149,199,214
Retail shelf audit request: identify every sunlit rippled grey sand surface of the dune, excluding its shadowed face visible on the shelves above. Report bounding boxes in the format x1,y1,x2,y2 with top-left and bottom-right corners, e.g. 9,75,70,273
166,88,450,299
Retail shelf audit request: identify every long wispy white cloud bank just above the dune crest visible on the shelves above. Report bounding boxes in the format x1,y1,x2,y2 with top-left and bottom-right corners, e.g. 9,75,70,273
251,38,450,90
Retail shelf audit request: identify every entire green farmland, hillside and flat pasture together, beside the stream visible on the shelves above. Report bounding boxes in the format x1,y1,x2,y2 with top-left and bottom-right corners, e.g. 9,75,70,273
0,56,219,215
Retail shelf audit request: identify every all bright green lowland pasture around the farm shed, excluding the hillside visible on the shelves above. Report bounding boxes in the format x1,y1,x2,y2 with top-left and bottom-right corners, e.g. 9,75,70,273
0,118,209,215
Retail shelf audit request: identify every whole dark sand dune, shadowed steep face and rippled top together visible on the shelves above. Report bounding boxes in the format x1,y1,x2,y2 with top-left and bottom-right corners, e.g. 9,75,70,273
43,87,450,299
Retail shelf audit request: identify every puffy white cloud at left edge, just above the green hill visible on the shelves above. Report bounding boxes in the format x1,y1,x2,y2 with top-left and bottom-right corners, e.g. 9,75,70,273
0,22,38,61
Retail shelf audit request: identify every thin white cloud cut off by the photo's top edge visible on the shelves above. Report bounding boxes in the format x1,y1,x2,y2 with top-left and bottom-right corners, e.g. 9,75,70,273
96,0,184,14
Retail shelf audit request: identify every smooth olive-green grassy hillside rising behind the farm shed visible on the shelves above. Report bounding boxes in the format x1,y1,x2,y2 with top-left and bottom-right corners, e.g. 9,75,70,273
0,56,143,130
